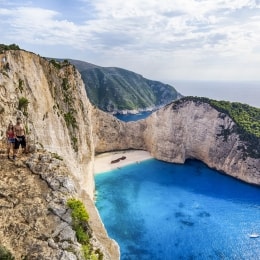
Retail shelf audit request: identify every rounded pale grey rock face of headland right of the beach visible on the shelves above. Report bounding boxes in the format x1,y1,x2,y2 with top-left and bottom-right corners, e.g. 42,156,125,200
144,101,260,185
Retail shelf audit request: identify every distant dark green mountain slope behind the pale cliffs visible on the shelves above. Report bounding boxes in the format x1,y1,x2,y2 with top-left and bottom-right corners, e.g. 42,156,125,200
69,60,181,112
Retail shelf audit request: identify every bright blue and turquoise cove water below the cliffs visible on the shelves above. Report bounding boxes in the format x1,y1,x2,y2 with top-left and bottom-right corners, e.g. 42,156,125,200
95,159,260,260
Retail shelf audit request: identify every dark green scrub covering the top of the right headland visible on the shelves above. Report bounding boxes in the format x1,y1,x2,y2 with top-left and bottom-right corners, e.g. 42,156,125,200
173,97,260,158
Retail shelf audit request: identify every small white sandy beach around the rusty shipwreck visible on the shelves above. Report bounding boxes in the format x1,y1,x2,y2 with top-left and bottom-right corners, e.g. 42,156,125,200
94,150,153,174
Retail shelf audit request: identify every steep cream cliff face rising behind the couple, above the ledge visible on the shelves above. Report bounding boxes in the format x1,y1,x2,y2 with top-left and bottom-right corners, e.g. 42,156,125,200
0,51,94,197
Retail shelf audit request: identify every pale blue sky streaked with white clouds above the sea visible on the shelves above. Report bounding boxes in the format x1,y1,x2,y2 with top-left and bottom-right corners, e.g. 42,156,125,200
0,0,260,82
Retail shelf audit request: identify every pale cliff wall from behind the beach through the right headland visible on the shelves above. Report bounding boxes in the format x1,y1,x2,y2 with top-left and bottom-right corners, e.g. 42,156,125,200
93,100,260,185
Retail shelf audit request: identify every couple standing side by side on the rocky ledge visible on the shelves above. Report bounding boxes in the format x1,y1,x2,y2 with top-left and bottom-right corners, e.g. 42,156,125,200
6,117,26,160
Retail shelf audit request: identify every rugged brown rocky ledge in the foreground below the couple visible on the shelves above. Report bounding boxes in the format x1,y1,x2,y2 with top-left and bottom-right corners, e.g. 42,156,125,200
0,147,119,260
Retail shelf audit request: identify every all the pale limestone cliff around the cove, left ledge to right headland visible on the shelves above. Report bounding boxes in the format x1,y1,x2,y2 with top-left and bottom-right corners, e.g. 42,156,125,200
0,47,260,260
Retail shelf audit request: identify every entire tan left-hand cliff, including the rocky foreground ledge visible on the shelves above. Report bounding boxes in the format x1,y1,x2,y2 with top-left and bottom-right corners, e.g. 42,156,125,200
0,50,119,259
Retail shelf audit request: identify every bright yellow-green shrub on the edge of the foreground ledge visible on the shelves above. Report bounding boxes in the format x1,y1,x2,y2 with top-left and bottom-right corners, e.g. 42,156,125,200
67,199,103,260
